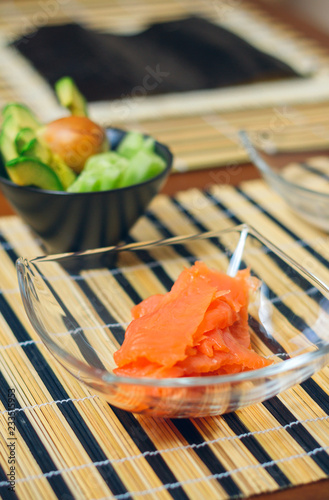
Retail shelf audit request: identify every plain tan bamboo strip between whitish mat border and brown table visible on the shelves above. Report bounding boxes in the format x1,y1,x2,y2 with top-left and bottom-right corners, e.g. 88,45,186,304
121,102,329,172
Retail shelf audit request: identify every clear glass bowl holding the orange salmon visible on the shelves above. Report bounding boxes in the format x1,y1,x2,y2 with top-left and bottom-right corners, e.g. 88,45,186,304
17,225,329,417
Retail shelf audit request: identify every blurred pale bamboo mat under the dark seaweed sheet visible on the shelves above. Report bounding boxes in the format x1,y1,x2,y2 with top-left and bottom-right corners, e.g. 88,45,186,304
0,0,329,171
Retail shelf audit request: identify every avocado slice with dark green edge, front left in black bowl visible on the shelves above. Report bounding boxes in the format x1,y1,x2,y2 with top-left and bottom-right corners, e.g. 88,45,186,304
6,156,63,191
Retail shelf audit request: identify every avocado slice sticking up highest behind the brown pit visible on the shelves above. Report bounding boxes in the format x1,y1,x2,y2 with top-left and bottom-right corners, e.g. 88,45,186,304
55,76,88,116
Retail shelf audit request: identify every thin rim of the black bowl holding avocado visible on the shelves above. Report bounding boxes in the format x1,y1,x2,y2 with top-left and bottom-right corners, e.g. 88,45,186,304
0,127,174,197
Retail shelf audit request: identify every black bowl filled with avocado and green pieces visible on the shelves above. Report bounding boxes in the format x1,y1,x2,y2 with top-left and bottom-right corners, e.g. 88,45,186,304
0,129,173,253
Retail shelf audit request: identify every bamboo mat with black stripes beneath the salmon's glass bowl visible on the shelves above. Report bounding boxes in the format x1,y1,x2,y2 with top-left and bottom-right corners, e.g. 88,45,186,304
0,180,329,500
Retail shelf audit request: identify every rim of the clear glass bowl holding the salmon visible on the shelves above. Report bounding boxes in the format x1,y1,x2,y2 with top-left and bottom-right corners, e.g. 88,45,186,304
16,223,329,388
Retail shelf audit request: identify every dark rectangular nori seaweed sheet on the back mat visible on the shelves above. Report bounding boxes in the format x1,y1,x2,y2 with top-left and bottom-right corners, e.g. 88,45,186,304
13,17,300,101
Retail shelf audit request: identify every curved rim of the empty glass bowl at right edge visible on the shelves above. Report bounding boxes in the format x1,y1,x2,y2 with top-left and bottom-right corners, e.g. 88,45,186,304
239,130,329,201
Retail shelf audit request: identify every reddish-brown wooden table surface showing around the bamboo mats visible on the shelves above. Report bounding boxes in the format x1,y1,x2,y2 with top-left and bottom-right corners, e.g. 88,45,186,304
0,0,329,500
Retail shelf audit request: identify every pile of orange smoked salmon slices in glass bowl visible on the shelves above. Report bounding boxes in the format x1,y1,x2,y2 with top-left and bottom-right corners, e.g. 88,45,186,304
114,261,271,378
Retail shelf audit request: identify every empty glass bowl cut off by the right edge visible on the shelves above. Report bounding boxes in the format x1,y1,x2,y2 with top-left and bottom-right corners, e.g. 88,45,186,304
240,126,329,231
